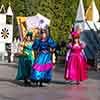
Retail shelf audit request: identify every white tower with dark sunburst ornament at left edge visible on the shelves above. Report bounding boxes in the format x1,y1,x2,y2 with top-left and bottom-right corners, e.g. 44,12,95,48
0,5,13,61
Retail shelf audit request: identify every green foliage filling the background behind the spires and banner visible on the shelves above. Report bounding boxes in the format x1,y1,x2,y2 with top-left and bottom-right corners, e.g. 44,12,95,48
0,0,100,42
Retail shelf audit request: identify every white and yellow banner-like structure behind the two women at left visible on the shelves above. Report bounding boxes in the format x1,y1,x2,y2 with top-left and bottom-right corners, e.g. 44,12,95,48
17,13,50,41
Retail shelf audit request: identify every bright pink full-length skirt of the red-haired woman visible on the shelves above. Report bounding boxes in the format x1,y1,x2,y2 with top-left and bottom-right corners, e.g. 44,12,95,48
64,54,87,81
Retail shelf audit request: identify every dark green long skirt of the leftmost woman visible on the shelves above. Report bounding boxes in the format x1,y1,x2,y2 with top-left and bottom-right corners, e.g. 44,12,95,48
16,56,32,80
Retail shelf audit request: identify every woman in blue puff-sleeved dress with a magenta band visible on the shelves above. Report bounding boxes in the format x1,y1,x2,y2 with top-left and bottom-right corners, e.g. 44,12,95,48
31,30,56,87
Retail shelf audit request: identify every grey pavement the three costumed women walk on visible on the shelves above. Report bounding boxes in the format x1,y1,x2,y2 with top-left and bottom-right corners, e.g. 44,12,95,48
0,63,100,100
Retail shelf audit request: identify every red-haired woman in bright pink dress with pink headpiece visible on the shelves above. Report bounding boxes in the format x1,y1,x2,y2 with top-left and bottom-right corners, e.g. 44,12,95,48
64,32,87,85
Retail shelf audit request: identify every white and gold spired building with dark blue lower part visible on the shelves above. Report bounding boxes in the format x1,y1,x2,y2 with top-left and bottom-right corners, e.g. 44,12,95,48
74,0,100,60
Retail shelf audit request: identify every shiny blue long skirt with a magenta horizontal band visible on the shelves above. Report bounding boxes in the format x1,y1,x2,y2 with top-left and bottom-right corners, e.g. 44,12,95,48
30,51,53,82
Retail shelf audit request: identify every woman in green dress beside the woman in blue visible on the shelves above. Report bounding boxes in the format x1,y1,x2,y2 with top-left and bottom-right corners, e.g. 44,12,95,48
16,32,35,84
